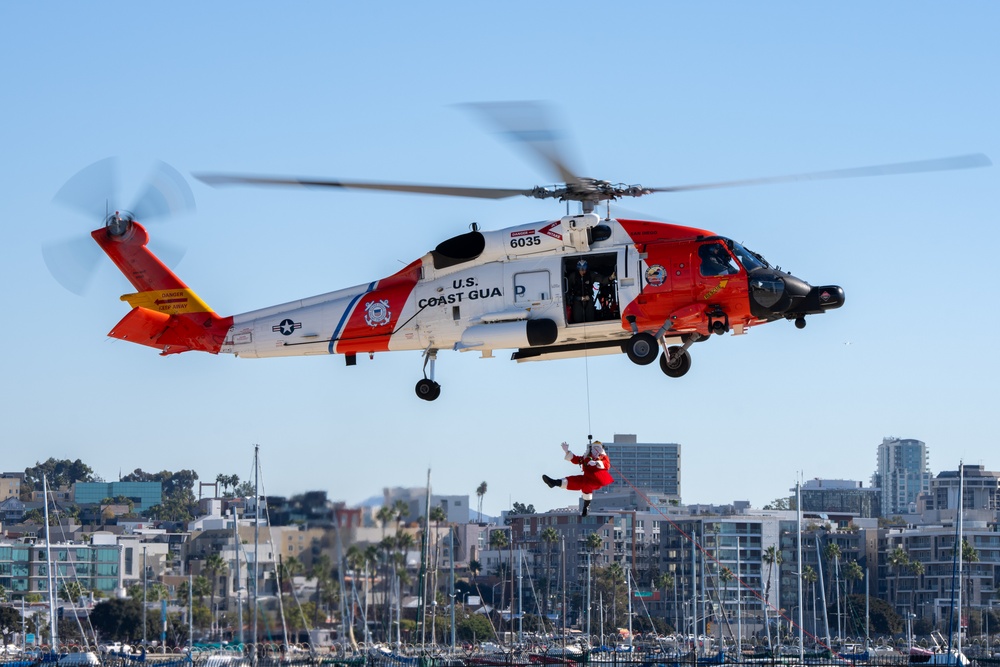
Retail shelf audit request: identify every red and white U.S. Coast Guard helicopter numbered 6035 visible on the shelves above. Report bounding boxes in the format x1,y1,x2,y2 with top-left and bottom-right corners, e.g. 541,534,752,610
46,103,991,401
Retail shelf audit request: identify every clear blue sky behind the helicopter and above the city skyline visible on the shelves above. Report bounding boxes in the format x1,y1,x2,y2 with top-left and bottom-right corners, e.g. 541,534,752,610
0,2,1000,514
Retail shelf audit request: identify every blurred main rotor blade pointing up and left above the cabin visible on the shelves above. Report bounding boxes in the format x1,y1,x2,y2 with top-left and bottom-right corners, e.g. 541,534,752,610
460,102,580,185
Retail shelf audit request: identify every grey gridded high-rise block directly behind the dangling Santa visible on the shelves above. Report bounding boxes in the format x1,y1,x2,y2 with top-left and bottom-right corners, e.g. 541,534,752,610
601,433,681,499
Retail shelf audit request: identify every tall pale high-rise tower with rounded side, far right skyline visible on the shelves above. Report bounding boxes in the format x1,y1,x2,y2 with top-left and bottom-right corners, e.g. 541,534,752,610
872,437,931,517
